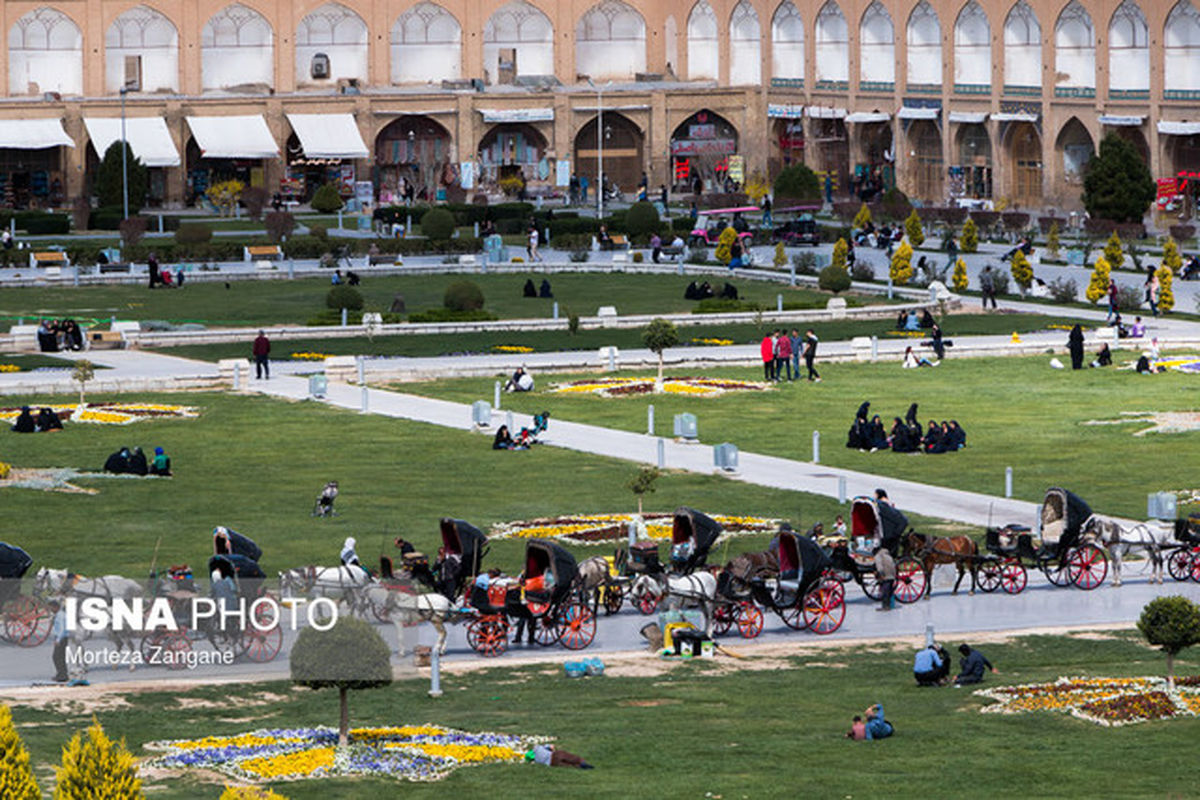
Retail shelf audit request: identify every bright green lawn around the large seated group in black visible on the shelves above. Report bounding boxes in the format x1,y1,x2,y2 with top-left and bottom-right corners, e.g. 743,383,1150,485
397,350,1200,523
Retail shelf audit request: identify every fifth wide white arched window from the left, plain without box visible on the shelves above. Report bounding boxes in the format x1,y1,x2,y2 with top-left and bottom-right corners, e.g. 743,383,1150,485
390,2,462,83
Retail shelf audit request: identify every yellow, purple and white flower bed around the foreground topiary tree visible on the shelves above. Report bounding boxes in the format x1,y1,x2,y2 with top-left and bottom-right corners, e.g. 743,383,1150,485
145,724,548,782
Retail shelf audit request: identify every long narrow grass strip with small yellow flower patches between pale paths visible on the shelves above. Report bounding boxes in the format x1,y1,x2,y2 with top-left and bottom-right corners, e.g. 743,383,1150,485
150,314,1088,361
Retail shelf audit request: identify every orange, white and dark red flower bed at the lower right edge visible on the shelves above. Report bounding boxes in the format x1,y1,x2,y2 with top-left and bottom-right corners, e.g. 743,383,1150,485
976,675,1200,727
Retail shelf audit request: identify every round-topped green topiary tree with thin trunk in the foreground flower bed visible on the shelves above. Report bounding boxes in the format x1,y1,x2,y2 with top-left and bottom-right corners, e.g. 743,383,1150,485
290,616,391,747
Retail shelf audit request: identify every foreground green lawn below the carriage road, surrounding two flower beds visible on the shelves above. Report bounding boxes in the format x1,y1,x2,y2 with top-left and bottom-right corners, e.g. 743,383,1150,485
14,632,1200,800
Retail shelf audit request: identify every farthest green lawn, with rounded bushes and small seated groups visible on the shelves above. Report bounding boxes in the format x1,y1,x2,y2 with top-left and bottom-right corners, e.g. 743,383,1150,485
0,272,887,326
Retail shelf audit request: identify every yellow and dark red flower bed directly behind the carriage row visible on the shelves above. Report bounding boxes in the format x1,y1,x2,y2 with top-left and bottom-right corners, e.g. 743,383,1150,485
491,513,780,545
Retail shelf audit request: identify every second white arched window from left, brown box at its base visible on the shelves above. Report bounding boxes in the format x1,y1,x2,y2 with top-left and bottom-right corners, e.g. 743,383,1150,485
104,6,179,92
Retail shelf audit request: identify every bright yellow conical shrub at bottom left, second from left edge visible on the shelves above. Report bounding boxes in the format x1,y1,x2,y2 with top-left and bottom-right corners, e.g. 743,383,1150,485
54,719,144,800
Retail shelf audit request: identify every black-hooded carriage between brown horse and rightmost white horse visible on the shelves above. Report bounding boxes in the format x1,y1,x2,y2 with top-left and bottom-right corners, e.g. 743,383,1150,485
978,487,1109,595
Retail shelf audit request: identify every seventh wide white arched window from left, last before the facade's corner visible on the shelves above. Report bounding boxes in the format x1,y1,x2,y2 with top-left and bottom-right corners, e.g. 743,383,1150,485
575,0,646,79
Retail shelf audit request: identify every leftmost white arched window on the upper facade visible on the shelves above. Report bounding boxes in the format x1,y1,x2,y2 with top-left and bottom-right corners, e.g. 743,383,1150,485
8,8,83,95
